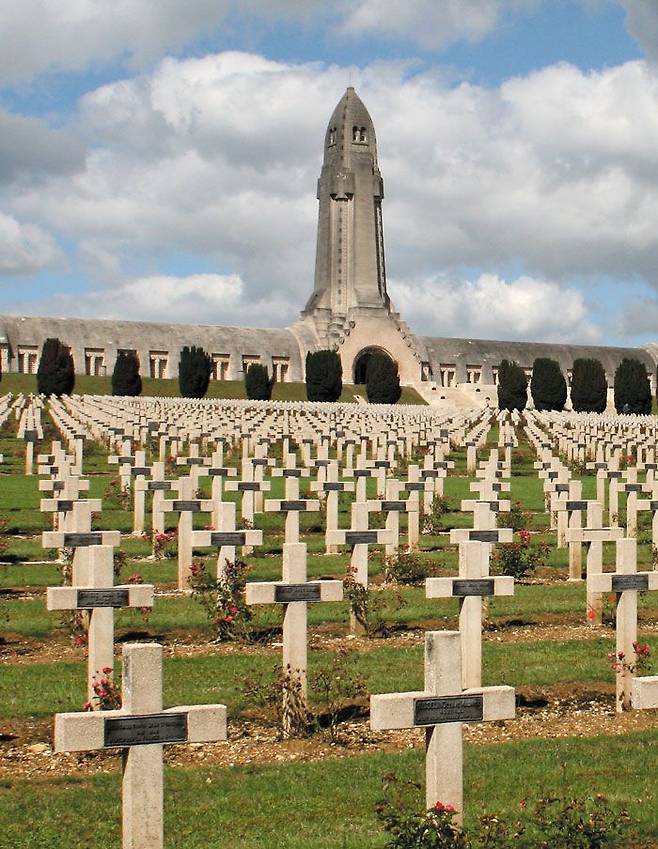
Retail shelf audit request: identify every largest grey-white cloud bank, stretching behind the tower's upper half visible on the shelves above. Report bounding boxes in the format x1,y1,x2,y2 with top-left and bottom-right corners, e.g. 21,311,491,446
6,52,658,339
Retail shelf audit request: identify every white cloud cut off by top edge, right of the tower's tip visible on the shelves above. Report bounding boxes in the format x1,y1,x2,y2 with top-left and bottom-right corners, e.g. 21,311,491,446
343,0,539,49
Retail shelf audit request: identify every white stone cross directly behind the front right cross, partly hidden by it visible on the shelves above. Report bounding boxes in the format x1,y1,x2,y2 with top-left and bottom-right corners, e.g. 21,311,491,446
425,542,514,687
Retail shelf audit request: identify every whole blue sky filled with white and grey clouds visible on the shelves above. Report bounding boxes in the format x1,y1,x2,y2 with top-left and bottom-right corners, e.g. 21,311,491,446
0,0,658,346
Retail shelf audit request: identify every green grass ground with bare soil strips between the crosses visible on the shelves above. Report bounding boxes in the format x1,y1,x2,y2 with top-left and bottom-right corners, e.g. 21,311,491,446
0,408,658,849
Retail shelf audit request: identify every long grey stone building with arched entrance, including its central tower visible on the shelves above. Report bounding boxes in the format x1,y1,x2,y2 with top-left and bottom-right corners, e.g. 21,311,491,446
0,87,658,406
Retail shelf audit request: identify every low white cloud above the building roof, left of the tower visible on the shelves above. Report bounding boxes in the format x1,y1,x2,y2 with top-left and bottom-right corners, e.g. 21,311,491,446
21,274,289,326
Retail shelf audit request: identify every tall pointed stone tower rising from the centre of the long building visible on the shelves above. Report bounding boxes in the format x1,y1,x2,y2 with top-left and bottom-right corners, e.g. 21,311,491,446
304,87,391,338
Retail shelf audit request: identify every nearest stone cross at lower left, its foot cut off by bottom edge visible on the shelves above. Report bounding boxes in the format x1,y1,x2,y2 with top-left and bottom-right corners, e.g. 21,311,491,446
55,643,226,849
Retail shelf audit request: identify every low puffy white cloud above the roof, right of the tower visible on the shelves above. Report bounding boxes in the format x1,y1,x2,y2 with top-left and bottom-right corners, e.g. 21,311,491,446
390,274,599,344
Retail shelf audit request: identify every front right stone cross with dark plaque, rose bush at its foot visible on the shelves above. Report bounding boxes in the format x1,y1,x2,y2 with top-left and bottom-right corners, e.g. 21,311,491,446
370,631,515,823
